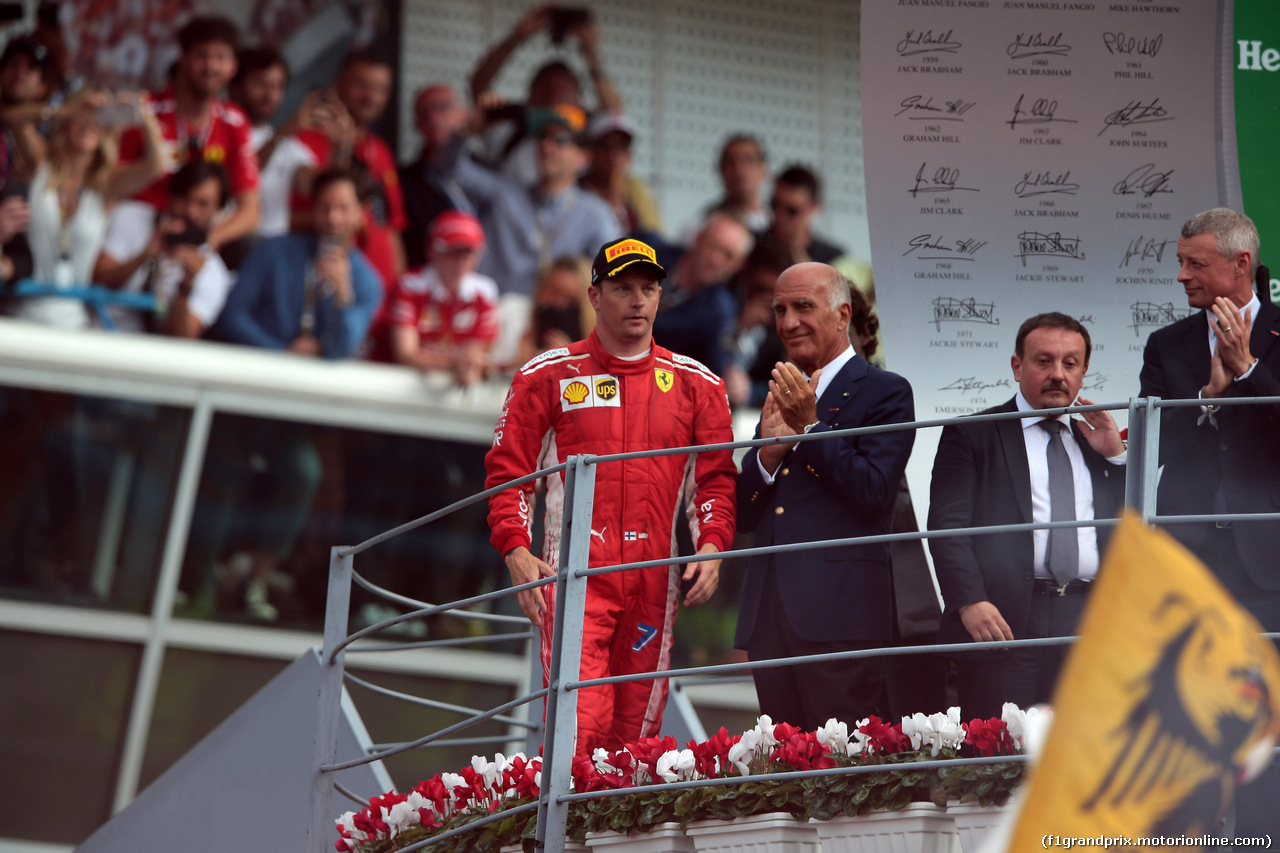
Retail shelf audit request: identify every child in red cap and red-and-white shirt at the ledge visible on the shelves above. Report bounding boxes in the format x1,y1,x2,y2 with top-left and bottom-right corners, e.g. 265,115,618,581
388,210,498,387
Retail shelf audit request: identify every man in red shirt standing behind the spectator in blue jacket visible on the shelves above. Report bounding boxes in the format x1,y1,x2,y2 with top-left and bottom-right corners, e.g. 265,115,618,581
297,50,408,292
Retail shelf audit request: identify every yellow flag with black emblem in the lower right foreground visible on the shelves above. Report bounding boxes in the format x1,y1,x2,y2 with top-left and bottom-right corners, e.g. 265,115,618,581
1009,515,1280,835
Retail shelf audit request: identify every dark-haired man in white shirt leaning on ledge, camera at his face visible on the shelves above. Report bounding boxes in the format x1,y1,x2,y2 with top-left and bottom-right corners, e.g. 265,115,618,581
93,160,232,338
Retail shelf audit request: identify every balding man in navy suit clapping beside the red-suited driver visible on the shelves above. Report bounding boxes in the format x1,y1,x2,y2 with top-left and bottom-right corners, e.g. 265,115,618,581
735,264,915,729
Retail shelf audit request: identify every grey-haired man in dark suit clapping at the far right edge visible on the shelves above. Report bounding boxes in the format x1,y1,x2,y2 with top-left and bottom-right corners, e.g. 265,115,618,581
1140,207,1280,631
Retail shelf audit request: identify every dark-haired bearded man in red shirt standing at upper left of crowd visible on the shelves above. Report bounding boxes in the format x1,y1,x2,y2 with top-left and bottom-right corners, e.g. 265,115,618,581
120,17,259,250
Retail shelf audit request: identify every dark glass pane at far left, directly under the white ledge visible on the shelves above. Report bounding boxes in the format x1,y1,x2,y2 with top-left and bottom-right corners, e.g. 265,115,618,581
0,387,191,612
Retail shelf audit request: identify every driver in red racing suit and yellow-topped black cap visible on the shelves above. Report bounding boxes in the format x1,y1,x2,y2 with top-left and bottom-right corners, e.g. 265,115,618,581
485,238,736,754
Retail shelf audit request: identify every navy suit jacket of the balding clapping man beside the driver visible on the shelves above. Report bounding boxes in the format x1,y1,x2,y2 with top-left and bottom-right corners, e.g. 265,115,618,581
733,356,915,649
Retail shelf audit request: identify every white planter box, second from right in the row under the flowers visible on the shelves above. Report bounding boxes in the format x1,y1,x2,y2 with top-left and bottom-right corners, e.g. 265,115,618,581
809,803,960,853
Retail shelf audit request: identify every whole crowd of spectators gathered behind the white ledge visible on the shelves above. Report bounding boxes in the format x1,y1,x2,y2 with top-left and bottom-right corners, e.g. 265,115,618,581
0,6,874,391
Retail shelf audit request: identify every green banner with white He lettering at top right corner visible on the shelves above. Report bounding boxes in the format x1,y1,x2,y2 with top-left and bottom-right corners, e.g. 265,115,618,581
1234,0,1280,304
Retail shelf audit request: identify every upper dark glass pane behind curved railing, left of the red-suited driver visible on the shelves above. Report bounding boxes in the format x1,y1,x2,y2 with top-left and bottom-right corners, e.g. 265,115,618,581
175,414,515,639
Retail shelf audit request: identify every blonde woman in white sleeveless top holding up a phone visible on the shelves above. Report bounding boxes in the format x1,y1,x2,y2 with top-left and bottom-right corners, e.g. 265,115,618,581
7,91,164,328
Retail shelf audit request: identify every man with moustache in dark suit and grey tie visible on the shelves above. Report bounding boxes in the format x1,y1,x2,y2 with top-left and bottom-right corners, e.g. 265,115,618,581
929,313,1125,719
